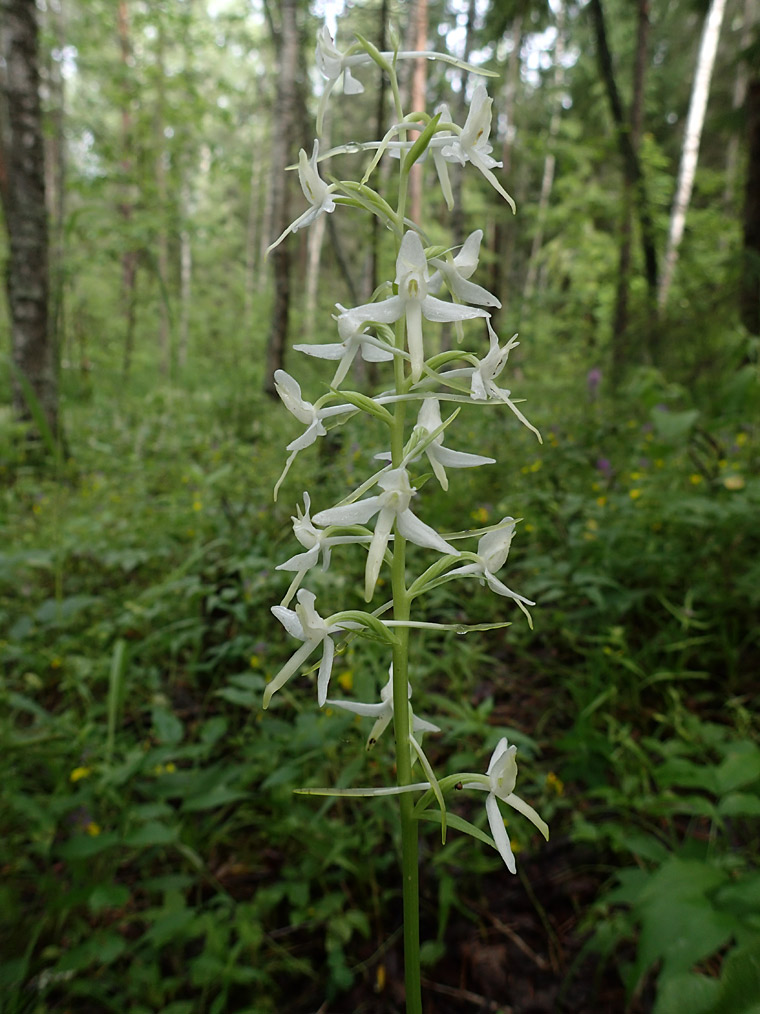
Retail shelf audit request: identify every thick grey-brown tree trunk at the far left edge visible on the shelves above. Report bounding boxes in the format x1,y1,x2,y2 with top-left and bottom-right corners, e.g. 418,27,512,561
0,0,60,438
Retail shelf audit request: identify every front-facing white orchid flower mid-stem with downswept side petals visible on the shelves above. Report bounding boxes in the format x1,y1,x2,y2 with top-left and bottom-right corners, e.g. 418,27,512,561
314,468,460,602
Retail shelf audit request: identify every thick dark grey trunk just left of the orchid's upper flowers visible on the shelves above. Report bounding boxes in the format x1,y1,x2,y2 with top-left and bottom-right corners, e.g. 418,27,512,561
263,0,299,397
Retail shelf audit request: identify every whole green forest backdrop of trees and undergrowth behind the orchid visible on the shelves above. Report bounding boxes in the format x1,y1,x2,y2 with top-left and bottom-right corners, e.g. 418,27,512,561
0,0,760,1014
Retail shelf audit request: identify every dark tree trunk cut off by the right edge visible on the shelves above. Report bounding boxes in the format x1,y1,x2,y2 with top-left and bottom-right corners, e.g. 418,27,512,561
740,82,760,335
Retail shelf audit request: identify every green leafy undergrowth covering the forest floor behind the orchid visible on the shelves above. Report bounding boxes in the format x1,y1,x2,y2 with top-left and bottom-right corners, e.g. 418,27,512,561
0,350,760,1014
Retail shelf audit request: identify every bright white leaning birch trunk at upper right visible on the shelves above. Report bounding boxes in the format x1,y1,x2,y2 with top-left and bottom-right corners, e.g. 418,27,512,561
657,0,726,312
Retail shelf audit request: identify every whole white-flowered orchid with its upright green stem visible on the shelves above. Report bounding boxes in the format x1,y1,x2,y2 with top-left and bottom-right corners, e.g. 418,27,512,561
263,21,548,1014
